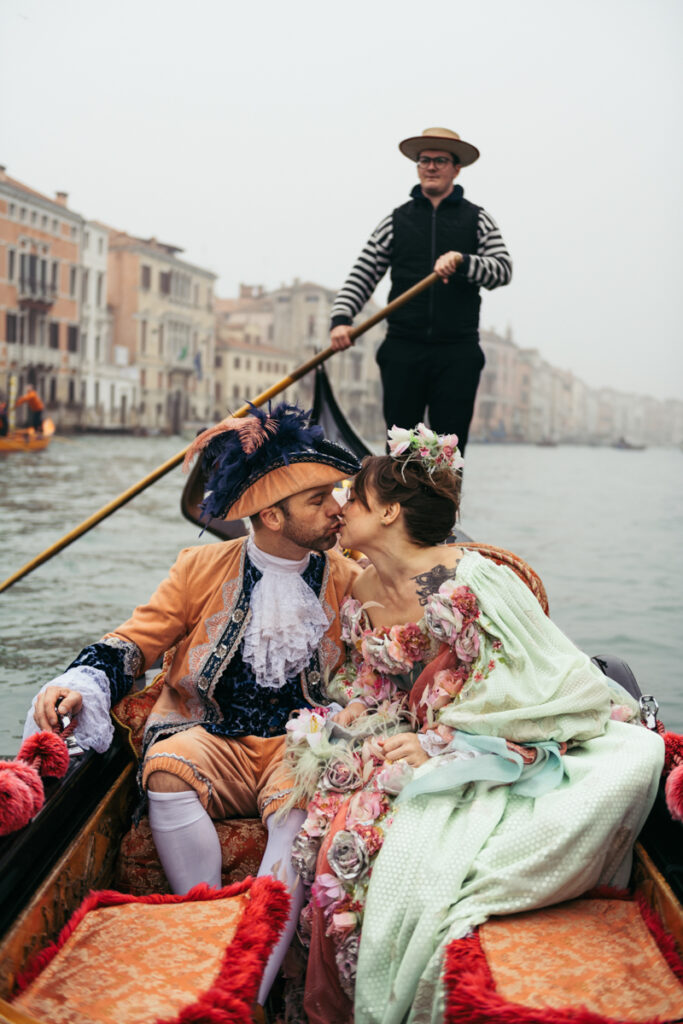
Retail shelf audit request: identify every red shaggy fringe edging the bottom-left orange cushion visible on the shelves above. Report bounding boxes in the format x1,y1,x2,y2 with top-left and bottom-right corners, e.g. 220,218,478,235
16,876,291,1024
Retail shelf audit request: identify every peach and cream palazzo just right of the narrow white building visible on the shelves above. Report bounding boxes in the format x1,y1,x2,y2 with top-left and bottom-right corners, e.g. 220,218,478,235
108,230,216,432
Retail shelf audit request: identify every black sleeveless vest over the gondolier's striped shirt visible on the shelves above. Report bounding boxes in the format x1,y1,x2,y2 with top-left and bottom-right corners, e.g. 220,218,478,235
388,185,481,342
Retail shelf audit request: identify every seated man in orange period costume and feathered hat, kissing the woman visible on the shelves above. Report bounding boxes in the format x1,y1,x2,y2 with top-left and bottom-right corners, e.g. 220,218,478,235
22,403,359,1019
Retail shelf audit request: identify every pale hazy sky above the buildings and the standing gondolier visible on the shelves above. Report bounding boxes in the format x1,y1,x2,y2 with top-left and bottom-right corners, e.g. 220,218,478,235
0,0,683,398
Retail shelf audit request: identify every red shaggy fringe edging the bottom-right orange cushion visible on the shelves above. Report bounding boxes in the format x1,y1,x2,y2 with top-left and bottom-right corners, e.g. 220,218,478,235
443,887,683,1024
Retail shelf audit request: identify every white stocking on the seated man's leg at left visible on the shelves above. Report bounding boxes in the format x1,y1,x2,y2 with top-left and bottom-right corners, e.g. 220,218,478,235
147,790,221,894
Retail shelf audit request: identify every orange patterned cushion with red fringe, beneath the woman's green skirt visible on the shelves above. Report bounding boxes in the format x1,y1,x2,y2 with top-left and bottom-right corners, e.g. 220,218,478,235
444,898,683,1024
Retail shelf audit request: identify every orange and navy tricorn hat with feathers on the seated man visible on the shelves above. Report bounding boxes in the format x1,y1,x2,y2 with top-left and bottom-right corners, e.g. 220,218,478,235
183,402,360,522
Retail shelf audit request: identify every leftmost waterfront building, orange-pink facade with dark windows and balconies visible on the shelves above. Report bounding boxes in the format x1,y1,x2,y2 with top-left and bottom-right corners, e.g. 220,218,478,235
0,167,83,425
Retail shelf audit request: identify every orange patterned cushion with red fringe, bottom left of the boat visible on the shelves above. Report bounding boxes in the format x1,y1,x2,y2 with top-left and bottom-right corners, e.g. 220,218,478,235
14,878,290,1024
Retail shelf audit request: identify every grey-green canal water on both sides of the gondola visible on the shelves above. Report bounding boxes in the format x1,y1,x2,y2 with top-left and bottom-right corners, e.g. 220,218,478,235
0,435,683,755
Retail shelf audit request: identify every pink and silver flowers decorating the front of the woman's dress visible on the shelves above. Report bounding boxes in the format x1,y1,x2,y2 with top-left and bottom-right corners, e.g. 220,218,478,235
287,580,504,999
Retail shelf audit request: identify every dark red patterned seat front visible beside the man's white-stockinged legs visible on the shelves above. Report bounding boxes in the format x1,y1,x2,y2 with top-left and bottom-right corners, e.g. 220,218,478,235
115,817,266,896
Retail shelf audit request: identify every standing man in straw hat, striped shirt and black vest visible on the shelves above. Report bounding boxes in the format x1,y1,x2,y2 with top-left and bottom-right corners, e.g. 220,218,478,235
330,128,512,452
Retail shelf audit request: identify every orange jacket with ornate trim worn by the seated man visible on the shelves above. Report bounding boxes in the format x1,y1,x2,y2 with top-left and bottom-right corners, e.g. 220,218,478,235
103,539,360,749
